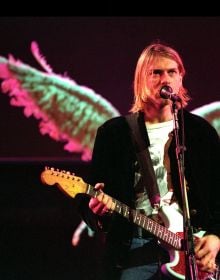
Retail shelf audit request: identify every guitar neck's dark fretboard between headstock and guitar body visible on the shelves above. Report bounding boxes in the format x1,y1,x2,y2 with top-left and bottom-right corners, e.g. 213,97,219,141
86,184,182,250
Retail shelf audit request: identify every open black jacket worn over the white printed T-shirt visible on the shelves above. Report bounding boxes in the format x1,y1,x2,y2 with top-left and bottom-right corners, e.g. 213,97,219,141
79,110,220,255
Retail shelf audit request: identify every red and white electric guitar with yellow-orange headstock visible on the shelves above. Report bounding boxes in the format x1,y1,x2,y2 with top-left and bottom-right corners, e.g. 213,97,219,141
41,167,217,280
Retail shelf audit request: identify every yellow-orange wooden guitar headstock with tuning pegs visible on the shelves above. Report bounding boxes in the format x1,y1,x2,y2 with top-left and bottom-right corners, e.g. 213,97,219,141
41,167,87,197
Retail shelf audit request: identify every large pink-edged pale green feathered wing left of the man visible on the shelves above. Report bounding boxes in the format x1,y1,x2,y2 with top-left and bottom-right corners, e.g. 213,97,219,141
0,42,119,160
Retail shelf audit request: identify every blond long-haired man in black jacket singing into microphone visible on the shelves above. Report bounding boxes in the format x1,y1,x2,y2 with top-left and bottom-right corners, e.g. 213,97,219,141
79,43,220,280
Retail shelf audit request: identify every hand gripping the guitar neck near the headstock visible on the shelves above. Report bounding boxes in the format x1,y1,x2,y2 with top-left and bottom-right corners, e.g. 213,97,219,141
89,183,115,216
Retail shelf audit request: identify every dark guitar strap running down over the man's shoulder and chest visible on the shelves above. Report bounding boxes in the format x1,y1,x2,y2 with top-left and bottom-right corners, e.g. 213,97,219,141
125,112,160,209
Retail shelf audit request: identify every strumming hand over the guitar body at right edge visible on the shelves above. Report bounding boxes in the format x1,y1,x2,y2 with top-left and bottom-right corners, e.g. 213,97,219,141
195,234,220,272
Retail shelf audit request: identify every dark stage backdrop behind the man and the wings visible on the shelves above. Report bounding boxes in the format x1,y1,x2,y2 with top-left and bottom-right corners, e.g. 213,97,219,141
0,17,220,280
